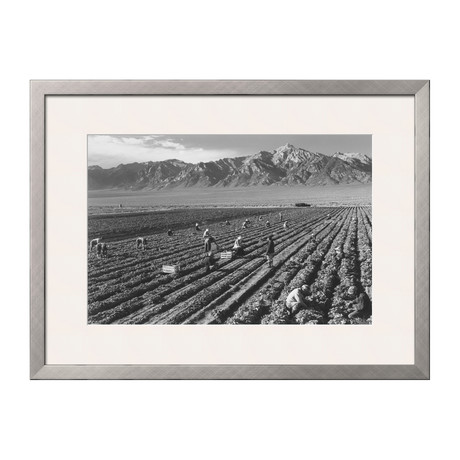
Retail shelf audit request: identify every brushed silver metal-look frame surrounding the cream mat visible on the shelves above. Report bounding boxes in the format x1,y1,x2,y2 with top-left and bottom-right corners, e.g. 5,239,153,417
30,80,430,379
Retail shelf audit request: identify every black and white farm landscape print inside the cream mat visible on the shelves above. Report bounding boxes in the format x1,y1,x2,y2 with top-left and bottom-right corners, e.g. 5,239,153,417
87,134,372,325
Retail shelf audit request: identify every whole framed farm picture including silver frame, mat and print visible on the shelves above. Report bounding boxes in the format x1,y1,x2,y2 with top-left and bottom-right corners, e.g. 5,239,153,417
30,80,429,379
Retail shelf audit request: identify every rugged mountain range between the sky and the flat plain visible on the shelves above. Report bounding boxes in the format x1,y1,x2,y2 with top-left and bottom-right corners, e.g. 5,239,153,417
88,144,372,190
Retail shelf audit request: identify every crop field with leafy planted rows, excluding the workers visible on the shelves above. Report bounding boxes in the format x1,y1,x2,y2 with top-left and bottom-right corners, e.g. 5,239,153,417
88,206,372,324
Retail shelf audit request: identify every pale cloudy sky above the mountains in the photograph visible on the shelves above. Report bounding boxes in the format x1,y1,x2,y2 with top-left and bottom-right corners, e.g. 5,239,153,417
88,134,372,168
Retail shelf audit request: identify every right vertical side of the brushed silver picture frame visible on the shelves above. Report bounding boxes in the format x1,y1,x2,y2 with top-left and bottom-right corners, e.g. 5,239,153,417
415,81,430,379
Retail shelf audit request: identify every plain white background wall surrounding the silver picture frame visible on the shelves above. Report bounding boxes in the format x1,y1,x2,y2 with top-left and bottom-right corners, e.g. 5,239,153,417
0,0,460,459
